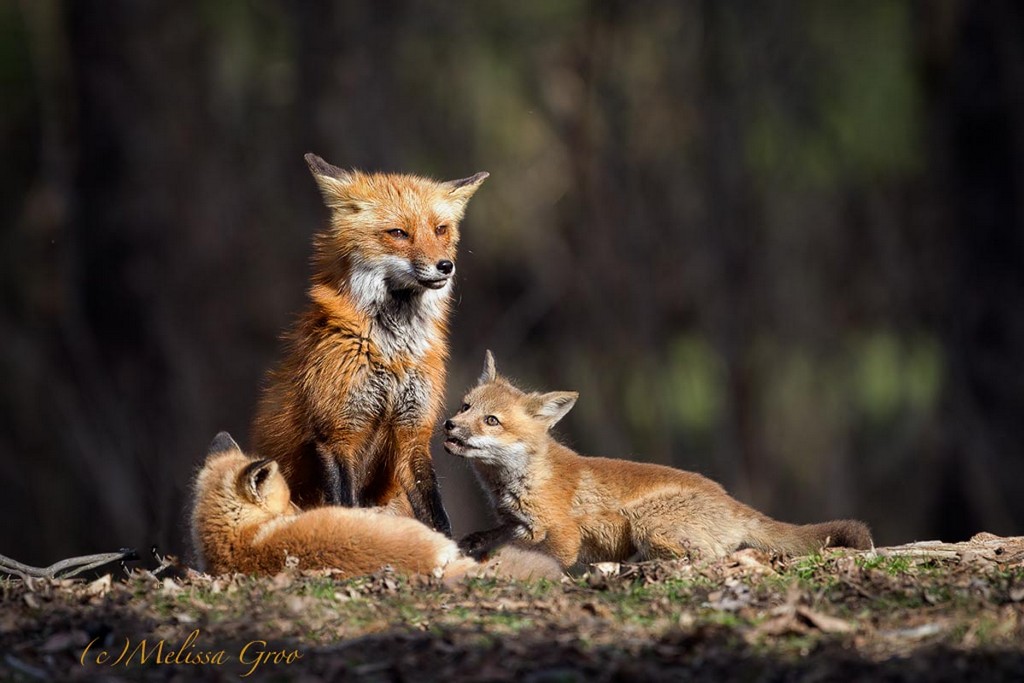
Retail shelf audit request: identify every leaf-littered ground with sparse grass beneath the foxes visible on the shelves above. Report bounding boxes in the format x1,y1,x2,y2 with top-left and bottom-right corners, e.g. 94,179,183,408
0,535,1024,683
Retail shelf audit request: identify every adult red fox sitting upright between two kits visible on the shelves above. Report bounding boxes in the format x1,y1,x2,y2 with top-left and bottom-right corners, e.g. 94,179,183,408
253,154,487,536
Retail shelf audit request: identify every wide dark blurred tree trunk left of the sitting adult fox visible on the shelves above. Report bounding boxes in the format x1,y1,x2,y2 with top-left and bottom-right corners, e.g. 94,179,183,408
54,0,208,549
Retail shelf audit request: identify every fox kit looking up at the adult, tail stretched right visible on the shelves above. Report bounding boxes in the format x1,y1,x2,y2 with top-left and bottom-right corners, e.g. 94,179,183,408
444,351,871,568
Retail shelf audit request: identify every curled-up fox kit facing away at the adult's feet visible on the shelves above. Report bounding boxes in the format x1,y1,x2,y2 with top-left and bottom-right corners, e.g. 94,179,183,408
191,432,560,579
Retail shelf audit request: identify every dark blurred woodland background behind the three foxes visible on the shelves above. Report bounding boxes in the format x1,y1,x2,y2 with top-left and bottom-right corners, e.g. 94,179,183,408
0,0,1024,563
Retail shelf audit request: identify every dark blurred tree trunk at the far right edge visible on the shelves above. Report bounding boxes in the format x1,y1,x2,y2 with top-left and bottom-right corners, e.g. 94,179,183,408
931,0,1024,540
